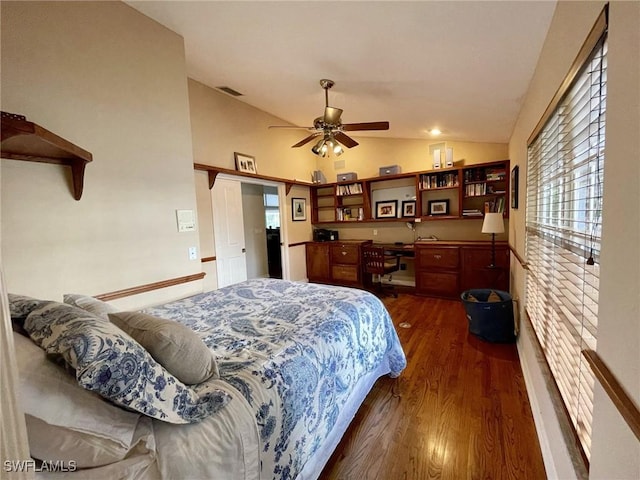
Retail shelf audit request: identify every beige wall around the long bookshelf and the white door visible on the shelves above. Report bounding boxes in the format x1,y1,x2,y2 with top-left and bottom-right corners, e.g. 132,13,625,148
189,80,508,264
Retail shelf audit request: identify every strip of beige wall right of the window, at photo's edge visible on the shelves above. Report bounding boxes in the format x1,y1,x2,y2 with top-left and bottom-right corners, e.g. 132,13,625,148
590,2,640,479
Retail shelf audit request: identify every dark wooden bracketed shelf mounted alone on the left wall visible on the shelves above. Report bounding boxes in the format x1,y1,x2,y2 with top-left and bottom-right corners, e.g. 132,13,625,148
1,112,93,200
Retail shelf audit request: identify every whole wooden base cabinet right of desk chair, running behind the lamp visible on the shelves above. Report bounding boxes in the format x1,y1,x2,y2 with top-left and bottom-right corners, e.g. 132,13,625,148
415,241,509,299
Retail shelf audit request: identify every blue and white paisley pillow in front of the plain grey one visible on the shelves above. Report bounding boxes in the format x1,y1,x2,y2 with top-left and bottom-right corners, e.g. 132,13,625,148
24,302,231,423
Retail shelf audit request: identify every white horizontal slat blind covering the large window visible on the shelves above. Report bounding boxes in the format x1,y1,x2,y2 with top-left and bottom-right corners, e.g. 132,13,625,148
526,25,607,461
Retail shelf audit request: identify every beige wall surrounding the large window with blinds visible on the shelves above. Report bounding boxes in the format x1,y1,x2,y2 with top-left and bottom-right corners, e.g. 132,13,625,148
509,2,640,479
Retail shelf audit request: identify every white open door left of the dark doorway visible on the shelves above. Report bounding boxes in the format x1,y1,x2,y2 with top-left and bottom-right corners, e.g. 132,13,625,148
211,177,247,288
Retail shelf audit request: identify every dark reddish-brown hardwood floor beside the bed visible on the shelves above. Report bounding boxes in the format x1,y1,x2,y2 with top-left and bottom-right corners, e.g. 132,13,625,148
320,294,546,480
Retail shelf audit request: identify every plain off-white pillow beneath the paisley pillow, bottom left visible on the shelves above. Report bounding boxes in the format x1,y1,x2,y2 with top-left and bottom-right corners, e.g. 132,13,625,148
13,332,141,467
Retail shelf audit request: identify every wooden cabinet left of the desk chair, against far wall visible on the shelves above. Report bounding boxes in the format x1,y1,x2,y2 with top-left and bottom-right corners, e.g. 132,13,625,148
306,240,371,287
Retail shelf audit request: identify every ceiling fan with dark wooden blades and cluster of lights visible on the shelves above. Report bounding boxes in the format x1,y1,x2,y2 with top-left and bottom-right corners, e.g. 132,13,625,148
269,78,389,157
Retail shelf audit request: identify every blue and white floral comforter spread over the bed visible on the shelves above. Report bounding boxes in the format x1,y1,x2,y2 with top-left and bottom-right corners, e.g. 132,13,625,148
145,279,406,479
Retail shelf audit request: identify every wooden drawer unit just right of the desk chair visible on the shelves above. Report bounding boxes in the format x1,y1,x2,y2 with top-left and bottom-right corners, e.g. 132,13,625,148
415,245,460,298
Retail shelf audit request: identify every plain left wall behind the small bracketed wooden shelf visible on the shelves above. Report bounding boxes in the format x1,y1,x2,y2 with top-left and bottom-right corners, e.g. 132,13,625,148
1,2,202,306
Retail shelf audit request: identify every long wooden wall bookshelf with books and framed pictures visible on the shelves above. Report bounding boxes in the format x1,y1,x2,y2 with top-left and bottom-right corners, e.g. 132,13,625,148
311,160,509,224
